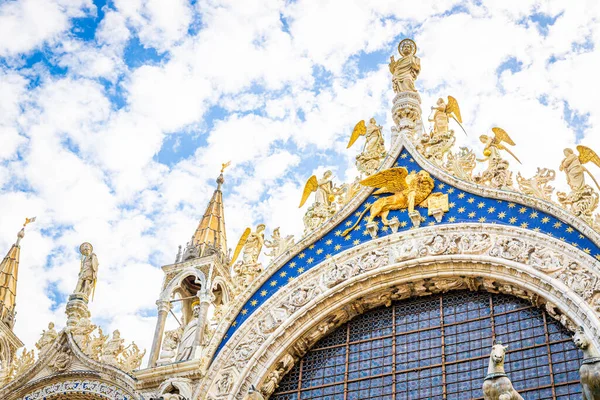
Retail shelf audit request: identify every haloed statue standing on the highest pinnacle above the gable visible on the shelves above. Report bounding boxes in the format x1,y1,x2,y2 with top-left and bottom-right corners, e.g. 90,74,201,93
389,39,421,93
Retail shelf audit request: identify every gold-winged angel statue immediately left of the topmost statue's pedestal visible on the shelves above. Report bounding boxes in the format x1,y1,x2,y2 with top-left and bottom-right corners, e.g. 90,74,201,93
347,118,387,176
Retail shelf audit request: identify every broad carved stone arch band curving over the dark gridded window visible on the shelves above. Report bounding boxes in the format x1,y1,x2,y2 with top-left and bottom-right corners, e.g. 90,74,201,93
199,224,600,399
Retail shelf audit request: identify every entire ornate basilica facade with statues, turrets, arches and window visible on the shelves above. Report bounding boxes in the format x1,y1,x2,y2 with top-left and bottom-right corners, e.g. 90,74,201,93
0,39,600,400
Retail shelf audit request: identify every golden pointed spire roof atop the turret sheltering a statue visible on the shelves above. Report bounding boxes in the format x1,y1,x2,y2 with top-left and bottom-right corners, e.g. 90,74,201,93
184,170,227,260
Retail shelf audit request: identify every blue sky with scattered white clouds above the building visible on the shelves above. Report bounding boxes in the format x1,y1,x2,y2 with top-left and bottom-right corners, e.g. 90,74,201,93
0,0,600,360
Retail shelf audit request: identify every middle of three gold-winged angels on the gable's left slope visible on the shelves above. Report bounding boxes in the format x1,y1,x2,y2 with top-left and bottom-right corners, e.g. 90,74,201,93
299,171,342,233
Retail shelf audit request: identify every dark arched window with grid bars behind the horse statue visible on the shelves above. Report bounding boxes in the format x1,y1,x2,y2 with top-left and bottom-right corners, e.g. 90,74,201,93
271,292,582,400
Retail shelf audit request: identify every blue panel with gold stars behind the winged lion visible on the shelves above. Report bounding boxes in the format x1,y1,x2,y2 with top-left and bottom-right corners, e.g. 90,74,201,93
217,150,600,353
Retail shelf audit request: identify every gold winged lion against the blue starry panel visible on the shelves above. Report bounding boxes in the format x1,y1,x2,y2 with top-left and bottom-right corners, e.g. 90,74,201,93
342,167,435,236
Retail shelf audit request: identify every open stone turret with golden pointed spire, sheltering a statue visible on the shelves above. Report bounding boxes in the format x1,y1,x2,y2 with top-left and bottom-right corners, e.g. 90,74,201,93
148,163,235,368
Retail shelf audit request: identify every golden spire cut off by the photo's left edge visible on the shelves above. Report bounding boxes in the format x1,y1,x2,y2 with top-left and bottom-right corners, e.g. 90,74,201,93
0,218,35,329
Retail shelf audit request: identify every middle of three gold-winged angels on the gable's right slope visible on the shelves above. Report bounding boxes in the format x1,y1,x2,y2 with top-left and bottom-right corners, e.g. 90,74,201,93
474,127,521,189
